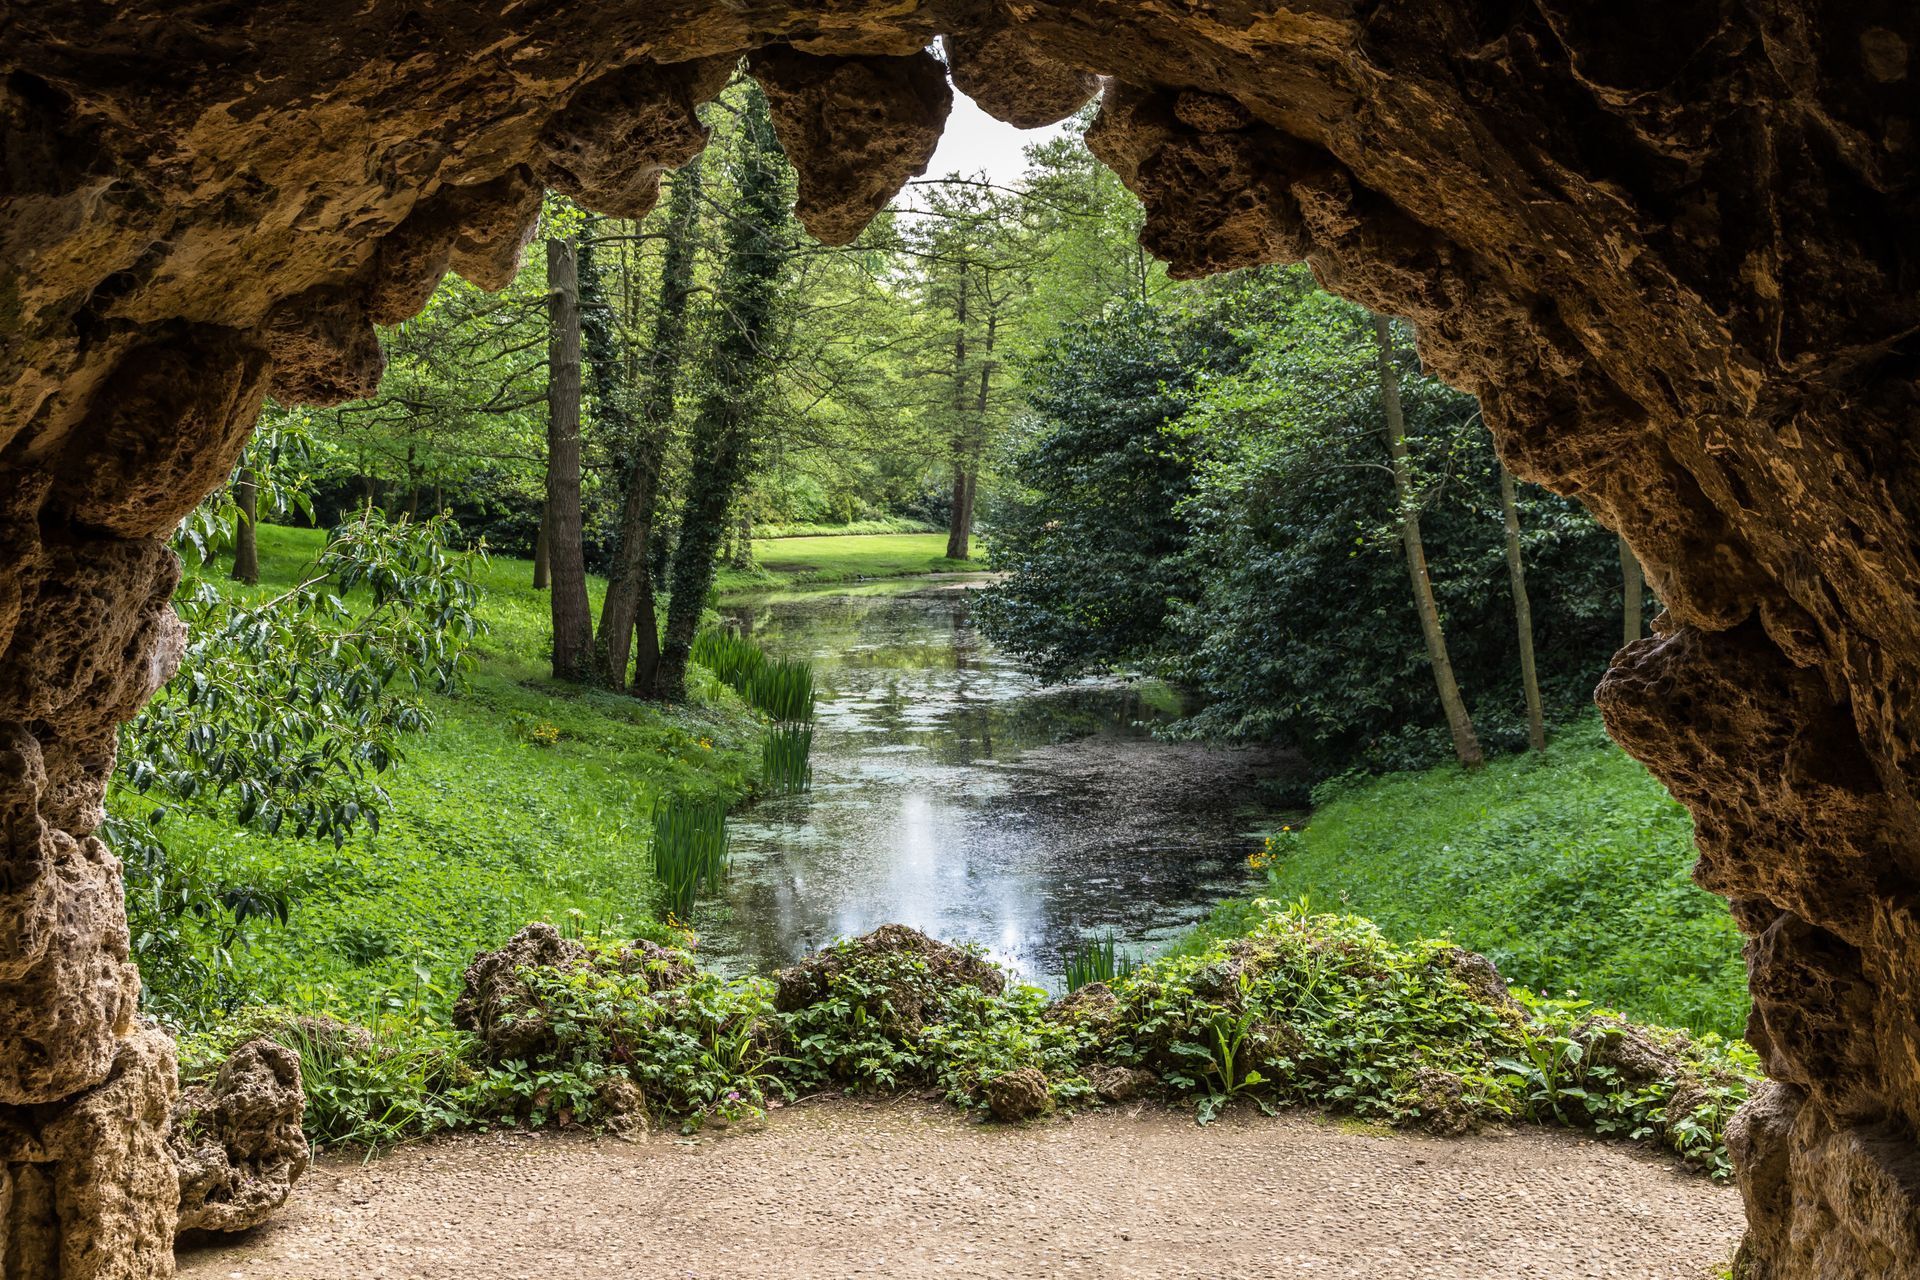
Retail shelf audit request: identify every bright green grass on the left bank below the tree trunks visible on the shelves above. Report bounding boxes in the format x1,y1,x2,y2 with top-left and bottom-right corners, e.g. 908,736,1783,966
117,526,762,1019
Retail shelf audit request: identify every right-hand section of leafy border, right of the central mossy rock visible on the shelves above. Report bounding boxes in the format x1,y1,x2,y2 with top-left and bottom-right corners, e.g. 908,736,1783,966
1102,900,1759,1176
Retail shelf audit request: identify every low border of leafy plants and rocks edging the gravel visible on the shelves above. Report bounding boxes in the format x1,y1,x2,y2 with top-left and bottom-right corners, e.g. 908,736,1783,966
186,900,1757,1176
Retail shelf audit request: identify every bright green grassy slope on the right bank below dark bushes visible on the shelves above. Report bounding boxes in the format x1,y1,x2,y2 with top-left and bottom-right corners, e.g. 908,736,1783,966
1204,720,1747,1036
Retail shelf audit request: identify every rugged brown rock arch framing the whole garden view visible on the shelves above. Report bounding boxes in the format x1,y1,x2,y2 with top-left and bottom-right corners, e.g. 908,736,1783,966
0,0,1920,1278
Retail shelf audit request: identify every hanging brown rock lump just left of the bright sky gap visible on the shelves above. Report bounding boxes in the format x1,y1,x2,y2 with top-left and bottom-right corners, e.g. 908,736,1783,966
749,44,952,244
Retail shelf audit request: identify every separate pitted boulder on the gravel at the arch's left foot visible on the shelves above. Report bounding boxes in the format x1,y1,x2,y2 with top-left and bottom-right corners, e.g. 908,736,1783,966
169,1040,309,1232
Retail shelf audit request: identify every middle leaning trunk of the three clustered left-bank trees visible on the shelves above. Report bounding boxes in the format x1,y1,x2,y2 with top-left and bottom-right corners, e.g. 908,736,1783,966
586,159,701,695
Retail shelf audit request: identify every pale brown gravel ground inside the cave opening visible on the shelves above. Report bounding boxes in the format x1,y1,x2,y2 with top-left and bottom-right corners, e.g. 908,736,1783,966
180,1102,1743,1280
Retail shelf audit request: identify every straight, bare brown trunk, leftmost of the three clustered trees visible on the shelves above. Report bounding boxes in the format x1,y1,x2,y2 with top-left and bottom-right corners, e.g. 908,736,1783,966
547,240,593,679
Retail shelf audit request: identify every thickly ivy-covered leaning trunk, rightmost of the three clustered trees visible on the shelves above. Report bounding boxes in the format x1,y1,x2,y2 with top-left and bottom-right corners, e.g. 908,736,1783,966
653,90,787,700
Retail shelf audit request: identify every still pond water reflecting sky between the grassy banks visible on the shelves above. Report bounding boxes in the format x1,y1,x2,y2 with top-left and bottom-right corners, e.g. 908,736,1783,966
701,578,1277,990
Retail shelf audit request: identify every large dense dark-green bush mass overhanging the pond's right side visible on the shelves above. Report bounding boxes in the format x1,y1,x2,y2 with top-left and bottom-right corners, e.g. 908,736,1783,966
979,271,1643,777
